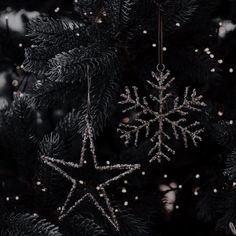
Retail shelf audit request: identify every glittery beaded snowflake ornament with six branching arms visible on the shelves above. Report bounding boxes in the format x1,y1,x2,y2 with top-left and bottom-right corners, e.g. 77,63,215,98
118,68,206,162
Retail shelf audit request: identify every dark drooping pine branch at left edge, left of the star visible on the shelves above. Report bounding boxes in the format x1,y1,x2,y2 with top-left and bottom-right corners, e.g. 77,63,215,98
1,94,38,175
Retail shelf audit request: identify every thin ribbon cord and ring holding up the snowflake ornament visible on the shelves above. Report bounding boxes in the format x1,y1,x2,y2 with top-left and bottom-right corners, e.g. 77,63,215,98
156,1,165,71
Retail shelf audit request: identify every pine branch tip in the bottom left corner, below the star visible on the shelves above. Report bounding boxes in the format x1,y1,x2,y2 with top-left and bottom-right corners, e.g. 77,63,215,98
0,213,62,236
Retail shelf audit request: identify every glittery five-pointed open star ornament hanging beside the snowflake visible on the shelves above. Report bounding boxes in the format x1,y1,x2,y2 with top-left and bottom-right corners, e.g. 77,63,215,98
41,116,140,231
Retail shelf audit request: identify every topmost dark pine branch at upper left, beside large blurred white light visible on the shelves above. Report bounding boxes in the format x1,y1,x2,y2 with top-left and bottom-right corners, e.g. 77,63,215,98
23,17,91,74
